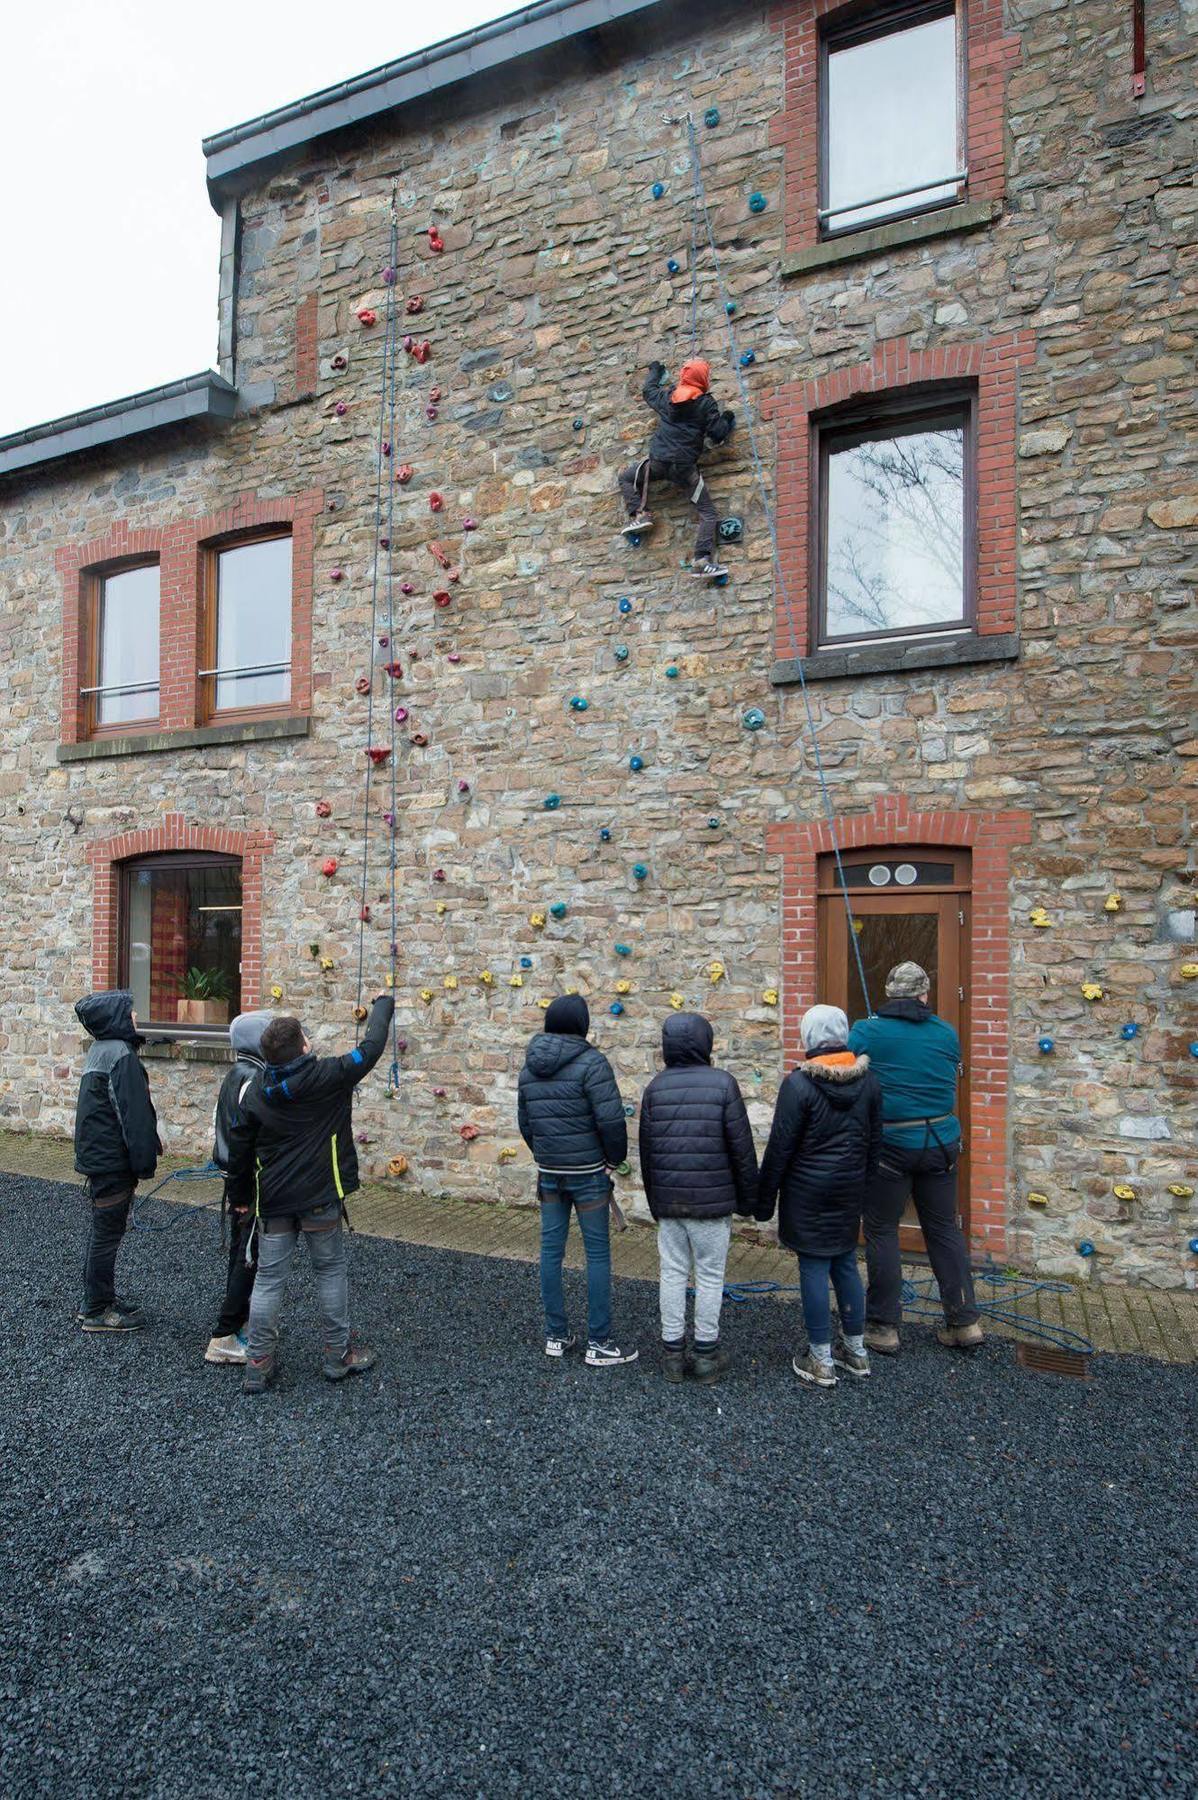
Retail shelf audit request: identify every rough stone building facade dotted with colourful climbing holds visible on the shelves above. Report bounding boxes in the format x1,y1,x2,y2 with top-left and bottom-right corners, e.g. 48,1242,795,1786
0,0,1198,1285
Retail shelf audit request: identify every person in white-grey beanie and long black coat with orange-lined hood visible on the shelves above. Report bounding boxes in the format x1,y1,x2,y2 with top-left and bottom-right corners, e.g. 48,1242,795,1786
757,1006,881,1388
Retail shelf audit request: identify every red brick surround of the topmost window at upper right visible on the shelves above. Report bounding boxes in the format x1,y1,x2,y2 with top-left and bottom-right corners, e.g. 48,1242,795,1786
770,0,1020,250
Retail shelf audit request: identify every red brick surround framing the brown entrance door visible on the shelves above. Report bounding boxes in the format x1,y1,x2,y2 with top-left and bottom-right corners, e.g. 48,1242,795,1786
766,794,1031,1256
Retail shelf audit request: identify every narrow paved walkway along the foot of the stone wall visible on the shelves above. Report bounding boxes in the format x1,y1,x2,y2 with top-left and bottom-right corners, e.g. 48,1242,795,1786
0,1132,1198,1363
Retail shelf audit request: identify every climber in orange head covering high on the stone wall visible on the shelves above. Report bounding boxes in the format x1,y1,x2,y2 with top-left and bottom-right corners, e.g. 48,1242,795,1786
621,358,736,581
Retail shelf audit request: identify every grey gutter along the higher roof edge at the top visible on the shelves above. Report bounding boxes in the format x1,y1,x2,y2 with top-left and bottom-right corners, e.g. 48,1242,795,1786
203,0,660,212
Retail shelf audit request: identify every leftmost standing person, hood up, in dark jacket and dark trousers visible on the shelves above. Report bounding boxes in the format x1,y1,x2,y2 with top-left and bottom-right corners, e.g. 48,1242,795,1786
76,988,162,1332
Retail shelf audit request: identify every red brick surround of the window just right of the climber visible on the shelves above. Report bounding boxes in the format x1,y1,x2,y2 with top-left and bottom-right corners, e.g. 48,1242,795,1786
761,331,1034,659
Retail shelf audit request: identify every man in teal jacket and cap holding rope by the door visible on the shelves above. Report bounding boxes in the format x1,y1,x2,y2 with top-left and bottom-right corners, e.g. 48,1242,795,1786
849,963,982,1355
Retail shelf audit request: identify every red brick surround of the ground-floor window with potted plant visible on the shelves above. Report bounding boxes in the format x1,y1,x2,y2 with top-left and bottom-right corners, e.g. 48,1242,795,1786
88,812,275,1012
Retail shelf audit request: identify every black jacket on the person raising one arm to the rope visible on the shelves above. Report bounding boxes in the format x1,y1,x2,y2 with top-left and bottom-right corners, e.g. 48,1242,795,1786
228,994,396,1219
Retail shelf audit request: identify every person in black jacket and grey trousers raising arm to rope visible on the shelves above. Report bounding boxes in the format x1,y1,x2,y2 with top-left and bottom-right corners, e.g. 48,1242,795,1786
228,994,396,1393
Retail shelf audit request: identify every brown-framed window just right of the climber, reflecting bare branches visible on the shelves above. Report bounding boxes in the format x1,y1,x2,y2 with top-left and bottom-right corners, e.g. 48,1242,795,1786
811,389,977,644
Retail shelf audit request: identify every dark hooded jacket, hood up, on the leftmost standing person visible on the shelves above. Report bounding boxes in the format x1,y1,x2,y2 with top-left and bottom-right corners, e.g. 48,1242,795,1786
76,988,162,1199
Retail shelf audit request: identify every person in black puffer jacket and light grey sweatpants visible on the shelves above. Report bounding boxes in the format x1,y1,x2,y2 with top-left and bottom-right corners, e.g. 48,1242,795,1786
640,1013,757,1386
